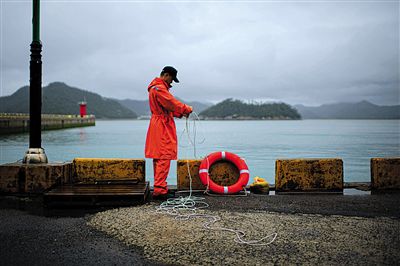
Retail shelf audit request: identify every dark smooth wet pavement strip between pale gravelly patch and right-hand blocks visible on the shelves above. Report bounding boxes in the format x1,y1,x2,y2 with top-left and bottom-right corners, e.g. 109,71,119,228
200,193,400,218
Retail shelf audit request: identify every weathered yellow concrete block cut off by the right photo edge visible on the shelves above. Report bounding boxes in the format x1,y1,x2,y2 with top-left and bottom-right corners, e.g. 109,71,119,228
371,158,400,190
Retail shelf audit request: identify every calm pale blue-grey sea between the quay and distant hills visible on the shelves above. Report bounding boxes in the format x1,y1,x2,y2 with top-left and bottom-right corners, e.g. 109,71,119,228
0,120,400,184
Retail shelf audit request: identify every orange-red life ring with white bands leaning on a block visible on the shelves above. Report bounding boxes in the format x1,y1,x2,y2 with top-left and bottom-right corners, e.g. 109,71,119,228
199,151,250,194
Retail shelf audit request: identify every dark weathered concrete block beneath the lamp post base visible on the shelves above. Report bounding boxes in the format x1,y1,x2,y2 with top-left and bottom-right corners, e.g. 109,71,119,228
0,162,72,193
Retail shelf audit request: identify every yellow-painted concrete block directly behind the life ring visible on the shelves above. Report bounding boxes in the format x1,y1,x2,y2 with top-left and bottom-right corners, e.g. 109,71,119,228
176,159,239,190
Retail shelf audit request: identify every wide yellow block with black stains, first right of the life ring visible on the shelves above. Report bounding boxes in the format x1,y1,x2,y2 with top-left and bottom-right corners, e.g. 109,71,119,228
275,158,343,193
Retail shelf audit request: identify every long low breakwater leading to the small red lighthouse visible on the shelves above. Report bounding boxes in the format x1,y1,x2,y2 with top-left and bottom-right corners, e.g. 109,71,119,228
0,113,96,135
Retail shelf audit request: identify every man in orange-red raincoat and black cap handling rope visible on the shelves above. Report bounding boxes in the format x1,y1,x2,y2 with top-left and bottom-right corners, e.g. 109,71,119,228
145,66,193,199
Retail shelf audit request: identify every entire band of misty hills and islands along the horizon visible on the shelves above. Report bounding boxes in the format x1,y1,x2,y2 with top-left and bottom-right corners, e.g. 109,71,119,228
0,82,400,120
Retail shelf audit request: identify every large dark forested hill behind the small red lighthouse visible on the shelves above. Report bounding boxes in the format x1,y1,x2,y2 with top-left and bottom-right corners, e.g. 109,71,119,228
0,82,137,118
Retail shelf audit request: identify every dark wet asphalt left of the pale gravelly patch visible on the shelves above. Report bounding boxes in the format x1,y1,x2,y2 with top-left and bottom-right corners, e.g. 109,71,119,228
0,197,159,265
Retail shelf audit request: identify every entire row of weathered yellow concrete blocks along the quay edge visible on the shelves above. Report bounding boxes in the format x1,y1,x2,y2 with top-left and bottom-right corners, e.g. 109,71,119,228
0,158,400,194
